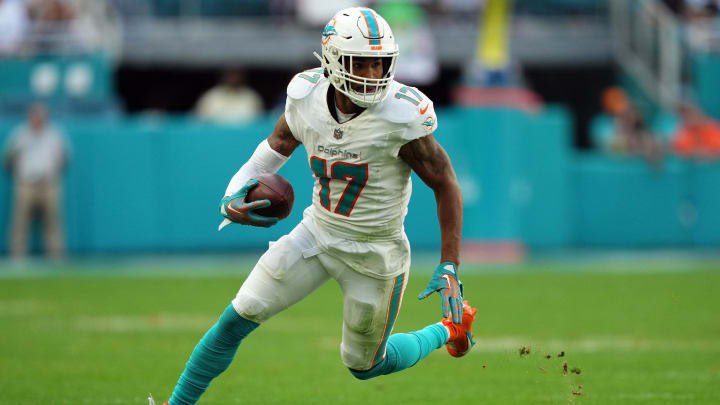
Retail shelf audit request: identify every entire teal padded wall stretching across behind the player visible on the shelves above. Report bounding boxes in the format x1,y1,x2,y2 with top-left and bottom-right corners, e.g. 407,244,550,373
0,108,720,252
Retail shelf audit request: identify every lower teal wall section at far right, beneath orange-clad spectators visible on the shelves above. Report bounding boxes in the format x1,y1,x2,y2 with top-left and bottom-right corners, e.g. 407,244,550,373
572,154,720,247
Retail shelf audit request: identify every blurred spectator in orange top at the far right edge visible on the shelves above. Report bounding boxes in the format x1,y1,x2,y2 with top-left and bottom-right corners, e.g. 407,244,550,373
672,102,720,159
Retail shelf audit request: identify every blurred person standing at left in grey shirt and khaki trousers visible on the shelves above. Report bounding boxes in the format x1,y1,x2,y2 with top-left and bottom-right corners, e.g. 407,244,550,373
4,104,69,259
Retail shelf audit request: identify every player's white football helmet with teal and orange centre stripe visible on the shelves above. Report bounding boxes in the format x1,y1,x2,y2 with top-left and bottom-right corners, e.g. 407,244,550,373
314,7,398,108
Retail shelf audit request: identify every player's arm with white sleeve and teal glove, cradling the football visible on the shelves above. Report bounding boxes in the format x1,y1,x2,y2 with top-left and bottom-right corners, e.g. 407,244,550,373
219,114,300,229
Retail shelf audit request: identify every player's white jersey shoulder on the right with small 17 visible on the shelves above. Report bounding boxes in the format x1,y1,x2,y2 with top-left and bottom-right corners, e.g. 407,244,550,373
379,82,433,124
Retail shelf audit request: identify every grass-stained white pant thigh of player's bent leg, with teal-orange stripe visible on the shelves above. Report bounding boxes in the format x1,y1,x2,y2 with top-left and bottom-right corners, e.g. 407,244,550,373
338,262,407,370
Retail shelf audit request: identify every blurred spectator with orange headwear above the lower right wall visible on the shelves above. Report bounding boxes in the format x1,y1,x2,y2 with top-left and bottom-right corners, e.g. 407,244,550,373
601,87,661,164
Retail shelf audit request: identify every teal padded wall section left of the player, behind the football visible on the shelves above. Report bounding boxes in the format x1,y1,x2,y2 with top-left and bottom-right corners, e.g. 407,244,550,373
0,115,312,252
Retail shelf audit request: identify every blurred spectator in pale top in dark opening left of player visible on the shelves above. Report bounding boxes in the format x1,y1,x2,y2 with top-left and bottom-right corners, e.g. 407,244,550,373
195,70,263,124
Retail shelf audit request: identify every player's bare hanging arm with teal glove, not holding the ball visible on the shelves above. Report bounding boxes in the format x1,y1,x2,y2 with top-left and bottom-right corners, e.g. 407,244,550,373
399,134,463,323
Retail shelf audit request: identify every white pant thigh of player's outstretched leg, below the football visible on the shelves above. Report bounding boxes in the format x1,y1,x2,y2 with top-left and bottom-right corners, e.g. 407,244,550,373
233,224,329,323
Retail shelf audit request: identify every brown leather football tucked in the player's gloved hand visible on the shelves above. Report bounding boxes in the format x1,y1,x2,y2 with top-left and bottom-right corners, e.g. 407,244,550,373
245,174,295,219
